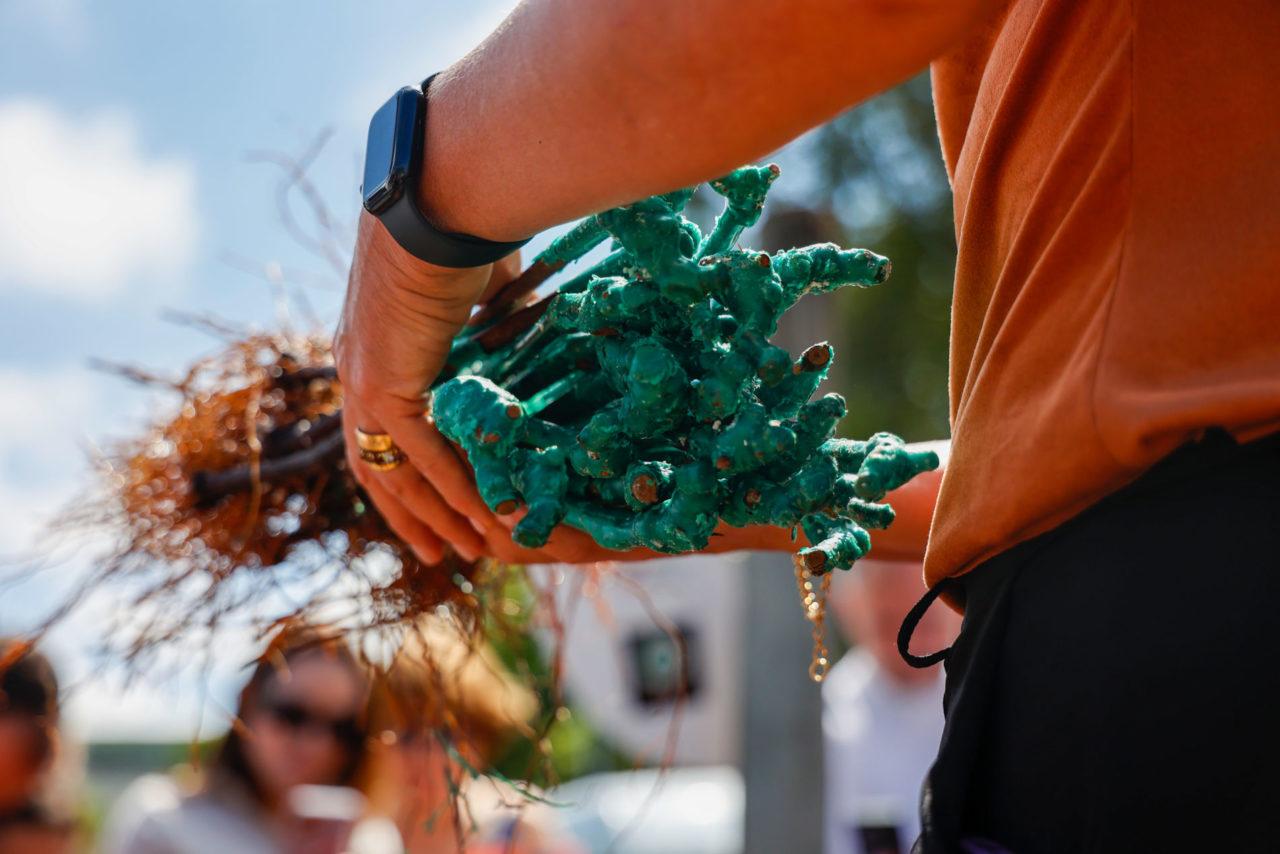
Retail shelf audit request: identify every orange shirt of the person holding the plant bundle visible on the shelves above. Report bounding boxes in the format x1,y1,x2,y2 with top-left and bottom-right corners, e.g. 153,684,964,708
925,0,1280,584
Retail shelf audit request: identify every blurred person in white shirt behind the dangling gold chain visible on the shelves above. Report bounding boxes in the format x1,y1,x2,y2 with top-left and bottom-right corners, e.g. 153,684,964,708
822,557,960,854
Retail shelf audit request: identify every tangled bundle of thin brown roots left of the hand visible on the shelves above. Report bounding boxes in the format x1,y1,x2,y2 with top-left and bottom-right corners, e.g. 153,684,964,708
46,333,484,661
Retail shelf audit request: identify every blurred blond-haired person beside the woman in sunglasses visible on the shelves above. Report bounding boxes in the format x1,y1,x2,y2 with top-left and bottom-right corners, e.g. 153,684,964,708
360,618,581,854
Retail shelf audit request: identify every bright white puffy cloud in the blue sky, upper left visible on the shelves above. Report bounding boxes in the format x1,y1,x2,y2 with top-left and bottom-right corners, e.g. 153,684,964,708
0,99,198,302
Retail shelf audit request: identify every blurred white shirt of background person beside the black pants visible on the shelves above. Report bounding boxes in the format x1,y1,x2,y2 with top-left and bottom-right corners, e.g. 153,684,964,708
822,649,945,854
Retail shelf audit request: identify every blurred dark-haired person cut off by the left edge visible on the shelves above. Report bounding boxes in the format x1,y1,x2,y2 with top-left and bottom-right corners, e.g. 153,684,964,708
0,638,78,854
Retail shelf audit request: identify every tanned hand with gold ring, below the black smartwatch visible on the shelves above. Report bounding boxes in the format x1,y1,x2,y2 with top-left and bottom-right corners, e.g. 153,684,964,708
333,213,520,563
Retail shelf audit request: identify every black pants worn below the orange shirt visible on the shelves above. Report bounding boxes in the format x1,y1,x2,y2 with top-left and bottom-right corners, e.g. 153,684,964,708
916,433,1280,853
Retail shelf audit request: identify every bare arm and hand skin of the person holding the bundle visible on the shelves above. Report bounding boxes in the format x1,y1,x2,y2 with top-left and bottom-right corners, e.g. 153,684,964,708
334,0,995,562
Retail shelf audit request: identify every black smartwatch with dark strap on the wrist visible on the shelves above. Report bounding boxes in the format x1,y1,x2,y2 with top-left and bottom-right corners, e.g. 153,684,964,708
360,74,529,268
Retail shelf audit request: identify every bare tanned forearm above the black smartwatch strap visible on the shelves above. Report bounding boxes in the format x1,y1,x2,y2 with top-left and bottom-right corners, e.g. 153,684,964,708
420,0,988,239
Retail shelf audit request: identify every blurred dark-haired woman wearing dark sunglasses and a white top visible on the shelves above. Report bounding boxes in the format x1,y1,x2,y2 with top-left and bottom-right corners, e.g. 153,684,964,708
102,625,401,854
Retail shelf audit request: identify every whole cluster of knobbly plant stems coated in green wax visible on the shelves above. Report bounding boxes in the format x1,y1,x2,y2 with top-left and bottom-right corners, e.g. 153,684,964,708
433,166,937,571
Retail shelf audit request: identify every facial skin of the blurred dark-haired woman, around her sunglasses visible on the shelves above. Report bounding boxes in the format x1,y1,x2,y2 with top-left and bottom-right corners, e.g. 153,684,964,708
244,652,364,809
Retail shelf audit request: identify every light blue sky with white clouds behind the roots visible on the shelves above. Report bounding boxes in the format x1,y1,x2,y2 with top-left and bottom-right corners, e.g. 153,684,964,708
0,0,536,739
